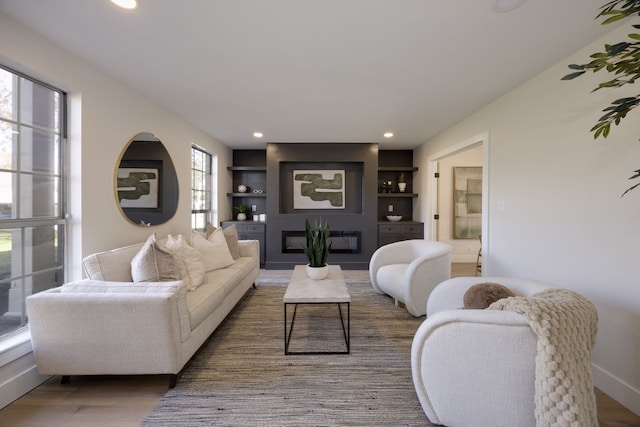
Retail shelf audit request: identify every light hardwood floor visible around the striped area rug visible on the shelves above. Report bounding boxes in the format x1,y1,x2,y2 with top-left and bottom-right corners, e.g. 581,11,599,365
0,264,640,427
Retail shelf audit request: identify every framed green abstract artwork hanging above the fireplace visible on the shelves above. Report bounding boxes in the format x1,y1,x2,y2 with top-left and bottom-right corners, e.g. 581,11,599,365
293,170,345,209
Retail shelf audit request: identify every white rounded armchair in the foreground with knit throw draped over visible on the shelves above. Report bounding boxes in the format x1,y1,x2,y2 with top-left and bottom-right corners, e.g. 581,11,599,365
411,277,557,427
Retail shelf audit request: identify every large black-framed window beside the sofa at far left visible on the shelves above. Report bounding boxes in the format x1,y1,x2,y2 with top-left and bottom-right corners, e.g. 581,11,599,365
0,67,66,338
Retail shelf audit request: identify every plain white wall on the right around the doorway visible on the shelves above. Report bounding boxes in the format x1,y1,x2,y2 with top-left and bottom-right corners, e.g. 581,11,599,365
414,20,640,414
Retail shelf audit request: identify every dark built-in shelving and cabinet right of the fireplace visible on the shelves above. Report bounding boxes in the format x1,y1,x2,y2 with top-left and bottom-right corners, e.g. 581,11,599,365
378,150,424,246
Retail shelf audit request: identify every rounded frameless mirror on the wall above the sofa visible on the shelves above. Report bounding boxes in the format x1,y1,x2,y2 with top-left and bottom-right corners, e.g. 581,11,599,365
115,133,178,226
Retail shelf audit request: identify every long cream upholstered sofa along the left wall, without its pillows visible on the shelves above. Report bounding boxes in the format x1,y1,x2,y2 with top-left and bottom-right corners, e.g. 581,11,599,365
26,231,260,386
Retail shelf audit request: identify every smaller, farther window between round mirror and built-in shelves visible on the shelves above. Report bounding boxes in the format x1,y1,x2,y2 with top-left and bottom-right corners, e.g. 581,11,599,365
191,146,213,231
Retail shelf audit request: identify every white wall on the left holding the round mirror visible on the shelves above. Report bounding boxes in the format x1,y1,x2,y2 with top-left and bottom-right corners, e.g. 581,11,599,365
0,13,231,407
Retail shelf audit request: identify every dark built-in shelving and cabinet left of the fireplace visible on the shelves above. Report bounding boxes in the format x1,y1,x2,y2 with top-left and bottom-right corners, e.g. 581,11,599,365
226,150,267,266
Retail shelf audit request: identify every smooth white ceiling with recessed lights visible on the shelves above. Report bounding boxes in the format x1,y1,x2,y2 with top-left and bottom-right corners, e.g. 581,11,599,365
0,0,613,149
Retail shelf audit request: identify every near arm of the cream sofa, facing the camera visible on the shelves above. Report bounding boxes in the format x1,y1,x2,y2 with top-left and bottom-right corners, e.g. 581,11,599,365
26,281,190,375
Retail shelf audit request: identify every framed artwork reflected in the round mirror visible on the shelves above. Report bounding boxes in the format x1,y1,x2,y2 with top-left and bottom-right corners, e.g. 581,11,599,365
117,161,162,211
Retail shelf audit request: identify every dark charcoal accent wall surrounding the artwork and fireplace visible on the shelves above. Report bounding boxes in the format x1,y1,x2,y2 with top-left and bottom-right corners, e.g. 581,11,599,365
265,143,378,270
